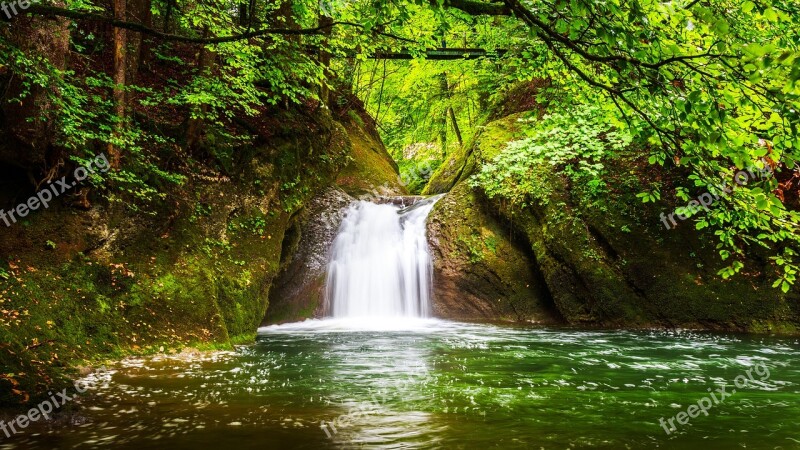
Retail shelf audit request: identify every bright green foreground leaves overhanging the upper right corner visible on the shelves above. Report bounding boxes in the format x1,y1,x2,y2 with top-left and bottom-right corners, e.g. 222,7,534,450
488,0,800,291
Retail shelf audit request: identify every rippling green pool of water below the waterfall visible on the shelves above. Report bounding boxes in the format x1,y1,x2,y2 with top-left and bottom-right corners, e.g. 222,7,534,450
0,319,800,450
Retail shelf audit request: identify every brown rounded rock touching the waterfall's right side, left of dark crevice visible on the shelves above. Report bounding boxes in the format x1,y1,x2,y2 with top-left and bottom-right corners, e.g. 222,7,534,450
428,184,562,323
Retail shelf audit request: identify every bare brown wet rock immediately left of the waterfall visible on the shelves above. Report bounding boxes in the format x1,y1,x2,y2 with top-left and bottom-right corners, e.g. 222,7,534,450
264,188,354,325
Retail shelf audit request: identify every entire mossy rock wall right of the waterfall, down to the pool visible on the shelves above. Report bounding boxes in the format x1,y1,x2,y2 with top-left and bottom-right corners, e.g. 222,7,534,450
427,82,800,334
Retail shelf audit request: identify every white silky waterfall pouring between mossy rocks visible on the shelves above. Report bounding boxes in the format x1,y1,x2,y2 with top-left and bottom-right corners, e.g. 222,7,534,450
325,196,441,318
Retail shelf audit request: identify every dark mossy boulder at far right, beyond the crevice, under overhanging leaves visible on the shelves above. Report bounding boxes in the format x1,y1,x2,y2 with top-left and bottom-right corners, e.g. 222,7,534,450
491,151,800,334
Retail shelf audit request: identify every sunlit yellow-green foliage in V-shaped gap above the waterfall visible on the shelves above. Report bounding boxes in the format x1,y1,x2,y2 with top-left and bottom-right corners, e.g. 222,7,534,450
346,7,515,193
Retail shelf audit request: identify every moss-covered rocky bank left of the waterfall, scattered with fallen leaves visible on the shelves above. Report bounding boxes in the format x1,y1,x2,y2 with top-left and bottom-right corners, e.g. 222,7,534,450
0,98,402,406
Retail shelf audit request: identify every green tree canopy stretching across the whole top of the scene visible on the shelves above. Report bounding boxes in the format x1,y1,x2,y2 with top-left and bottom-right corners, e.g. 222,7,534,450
0,0,800,291
